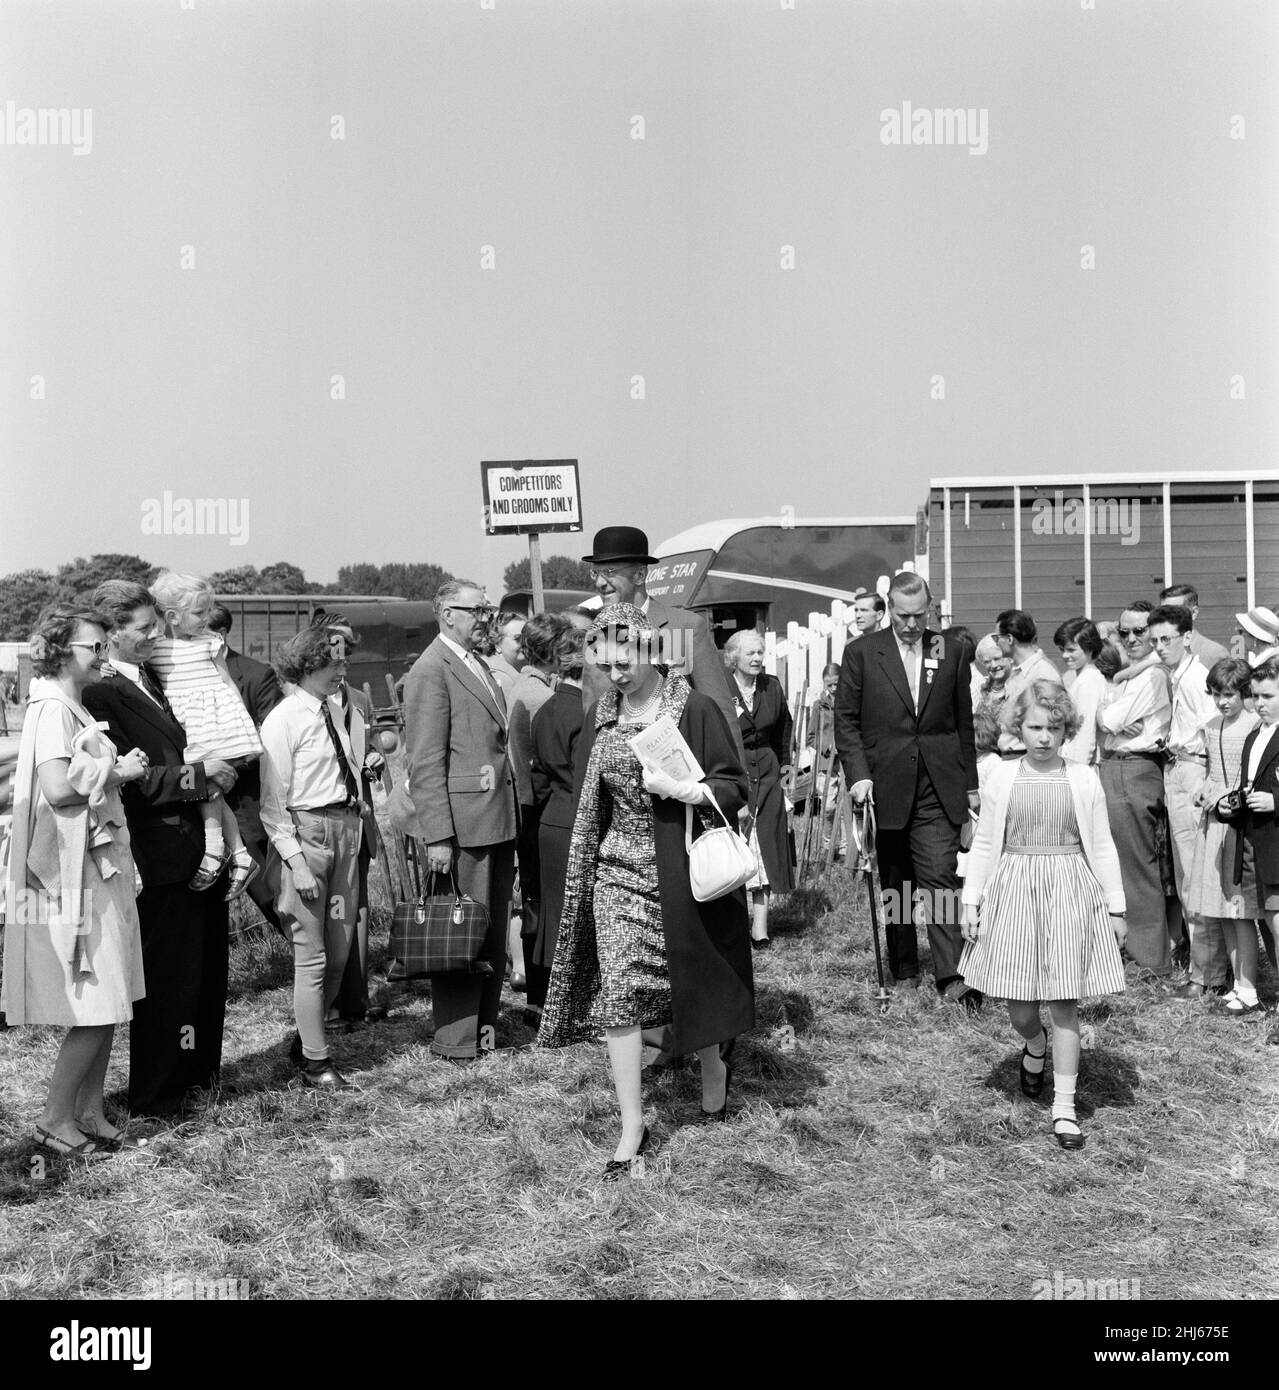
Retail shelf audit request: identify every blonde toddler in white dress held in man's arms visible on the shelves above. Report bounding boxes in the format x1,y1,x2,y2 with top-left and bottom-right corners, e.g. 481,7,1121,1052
150,570,261,902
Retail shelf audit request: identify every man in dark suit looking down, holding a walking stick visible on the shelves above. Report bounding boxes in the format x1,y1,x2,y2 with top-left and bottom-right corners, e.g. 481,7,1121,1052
836,573,981,1012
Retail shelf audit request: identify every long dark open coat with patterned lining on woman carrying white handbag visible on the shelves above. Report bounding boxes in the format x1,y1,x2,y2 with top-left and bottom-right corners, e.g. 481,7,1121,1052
538,676,755,1055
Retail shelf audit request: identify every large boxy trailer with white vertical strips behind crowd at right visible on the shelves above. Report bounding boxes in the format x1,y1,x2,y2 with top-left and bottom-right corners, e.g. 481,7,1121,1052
916,471,1279,649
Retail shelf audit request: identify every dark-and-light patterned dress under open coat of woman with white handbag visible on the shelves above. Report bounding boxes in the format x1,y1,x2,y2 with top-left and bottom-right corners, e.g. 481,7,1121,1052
595,723,670,1029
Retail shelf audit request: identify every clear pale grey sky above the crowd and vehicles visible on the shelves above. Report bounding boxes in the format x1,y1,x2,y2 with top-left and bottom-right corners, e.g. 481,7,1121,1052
0,0,1279,589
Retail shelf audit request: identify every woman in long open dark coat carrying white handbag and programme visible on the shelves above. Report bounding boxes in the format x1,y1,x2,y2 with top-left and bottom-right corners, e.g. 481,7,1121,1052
538,603,755,1177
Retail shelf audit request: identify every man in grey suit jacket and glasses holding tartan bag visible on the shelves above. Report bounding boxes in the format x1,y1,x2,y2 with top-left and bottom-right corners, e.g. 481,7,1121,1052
405,580,517,1061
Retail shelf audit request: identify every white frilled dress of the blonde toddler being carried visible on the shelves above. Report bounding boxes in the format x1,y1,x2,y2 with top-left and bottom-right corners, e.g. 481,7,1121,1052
150,632,261,763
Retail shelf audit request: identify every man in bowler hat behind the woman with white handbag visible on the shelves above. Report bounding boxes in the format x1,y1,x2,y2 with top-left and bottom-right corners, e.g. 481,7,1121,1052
583,525,745,758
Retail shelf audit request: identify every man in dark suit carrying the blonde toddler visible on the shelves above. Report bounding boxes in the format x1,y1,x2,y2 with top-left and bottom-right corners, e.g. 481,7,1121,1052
85,580,235,1115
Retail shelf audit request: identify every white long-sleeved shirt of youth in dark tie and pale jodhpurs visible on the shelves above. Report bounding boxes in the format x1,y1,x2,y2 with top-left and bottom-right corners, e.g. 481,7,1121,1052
261,687,360,859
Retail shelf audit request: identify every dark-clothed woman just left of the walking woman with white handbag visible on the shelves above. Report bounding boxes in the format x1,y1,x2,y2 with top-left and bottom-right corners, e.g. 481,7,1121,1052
528,623,585,1013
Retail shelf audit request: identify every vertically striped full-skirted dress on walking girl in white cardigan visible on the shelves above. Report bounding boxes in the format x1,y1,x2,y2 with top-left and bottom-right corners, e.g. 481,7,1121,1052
959,763,1123,1001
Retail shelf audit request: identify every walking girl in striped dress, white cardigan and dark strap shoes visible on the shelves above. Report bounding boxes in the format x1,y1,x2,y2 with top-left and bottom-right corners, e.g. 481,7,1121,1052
959,681,1127,1148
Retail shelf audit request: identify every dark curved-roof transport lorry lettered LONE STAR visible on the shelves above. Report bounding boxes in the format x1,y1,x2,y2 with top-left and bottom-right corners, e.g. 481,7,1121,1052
648,513,924,646
